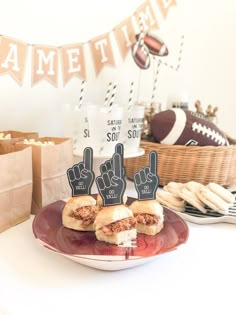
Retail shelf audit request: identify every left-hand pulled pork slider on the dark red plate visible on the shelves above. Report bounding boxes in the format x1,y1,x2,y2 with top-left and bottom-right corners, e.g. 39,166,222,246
62,196,100,231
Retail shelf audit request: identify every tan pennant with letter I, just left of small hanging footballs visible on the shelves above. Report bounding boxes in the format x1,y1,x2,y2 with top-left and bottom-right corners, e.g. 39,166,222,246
114,17,136,59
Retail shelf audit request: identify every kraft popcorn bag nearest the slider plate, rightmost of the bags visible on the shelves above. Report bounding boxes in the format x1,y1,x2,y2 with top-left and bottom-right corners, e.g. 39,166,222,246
16,137,73,214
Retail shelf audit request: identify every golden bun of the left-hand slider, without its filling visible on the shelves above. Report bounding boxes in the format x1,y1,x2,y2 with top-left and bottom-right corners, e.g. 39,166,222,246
62,196,96,231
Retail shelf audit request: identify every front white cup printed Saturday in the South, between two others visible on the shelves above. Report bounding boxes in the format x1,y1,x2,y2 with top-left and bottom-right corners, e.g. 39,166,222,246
87,104,123,156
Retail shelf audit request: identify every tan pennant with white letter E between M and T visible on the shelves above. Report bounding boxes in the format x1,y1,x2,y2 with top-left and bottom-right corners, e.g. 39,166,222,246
61,44,86,85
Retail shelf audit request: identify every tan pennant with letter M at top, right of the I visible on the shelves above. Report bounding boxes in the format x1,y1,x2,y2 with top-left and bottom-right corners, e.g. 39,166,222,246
135,0,159,32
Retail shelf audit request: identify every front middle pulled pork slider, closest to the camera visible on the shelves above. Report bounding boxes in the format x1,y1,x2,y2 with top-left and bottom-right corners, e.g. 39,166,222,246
94,205,137,245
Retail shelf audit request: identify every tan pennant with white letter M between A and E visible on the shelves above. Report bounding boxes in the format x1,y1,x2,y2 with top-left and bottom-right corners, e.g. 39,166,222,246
32,45,58,87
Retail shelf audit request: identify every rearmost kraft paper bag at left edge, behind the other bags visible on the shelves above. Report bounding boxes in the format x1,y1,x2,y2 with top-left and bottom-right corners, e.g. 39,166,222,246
0,130,38,153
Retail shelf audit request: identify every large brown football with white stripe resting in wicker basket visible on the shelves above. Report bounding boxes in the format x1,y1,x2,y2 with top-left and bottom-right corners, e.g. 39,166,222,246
150,108,228,146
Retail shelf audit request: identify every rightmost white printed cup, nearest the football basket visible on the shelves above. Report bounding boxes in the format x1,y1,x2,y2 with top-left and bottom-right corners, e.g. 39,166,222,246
121,105,144,154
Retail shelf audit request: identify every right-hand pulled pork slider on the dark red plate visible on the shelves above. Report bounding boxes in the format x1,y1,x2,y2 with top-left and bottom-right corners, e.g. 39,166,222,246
129,200,164,235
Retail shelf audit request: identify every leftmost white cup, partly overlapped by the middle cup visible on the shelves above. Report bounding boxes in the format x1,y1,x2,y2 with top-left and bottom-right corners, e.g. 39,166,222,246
63,105,91,154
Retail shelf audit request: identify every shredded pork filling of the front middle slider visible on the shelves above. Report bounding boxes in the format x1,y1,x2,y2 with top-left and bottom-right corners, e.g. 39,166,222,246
101,217,136,236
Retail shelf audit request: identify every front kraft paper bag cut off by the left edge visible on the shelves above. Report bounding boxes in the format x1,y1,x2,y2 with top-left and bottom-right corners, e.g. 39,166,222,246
0,148,33,232
